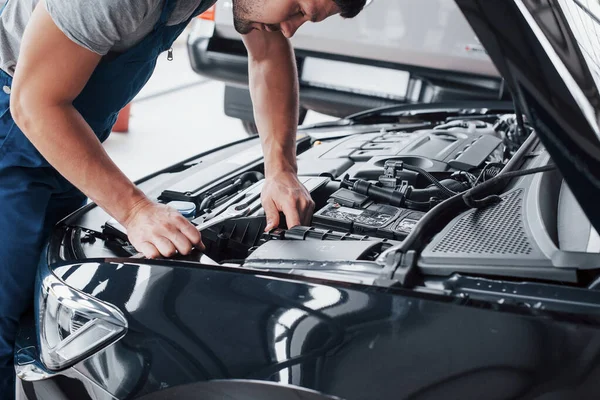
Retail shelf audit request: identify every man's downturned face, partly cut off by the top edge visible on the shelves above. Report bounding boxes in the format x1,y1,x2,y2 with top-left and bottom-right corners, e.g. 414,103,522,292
232,0,340,38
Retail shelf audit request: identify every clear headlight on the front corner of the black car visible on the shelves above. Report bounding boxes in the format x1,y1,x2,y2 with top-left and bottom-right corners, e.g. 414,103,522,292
37,273,127,371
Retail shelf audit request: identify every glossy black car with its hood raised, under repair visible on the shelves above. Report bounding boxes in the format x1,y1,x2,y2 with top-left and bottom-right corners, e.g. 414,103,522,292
15,0,600,400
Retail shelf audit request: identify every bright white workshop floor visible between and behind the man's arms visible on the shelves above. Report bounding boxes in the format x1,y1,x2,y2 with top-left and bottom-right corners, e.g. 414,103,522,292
104,31,334,180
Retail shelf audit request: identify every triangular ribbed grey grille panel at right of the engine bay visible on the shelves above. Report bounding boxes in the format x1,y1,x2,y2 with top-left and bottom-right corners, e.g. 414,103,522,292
432,189,533,255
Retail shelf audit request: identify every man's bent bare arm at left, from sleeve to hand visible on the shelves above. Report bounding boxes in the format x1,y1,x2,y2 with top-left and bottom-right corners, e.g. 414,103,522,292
10,1,200,257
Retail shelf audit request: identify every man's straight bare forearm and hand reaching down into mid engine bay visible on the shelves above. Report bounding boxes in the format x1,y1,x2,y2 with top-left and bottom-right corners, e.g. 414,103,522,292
243,30,314,230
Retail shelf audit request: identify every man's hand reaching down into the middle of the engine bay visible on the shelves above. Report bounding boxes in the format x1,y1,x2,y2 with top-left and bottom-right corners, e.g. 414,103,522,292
261,172,315,231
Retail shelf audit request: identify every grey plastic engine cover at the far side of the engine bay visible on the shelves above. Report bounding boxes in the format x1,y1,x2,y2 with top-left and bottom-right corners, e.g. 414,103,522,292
298,121,503,180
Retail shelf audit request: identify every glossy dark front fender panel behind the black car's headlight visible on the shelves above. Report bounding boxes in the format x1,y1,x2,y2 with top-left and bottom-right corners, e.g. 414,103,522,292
16,260,600,400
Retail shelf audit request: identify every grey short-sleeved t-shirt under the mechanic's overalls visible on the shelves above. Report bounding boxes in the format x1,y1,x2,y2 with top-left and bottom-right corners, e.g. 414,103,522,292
0,0,211,75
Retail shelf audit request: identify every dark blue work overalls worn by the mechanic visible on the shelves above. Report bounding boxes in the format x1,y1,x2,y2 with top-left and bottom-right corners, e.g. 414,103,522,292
0,0,216,400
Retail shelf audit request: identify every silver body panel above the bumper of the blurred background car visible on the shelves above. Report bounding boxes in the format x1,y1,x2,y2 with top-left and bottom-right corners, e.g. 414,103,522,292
215,0,498,76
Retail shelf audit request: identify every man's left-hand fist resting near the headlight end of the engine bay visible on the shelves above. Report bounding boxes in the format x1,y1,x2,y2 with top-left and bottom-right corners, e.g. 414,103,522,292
123,199,204,258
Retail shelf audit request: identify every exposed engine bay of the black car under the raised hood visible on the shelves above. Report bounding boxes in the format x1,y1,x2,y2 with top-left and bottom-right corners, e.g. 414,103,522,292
58,106,600,296
